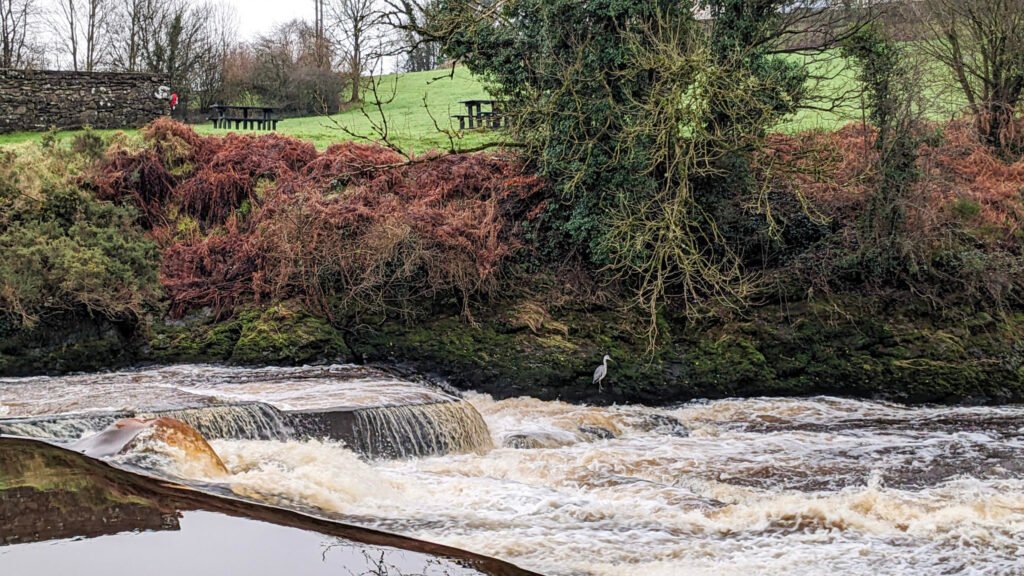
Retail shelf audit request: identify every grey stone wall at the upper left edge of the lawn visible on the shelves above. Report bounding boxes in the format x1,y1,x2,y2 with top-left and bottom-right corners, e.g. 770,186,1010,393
0,70,168,132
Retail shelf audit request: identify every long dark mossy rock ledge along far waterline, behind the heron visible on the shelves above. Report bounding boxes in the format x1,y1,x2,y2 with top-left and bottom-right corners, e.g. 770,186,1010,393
350,299,1024,404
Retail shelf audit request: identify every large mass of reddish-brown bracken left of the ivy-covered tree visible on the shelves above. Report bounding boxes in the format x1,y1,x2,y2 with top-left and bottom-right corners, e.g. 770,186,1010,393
105,120,543,316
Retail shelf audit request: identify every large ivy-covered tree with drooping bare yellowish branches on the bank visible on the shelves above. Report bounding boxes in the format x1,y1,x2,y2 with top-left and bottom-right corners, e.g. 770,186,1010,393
427,0,870,330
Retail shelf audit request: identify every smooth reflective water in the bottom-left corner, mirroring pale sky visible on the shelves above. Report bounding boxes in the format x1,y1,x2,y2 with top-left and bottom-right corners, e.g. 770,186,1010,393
0,438,531,576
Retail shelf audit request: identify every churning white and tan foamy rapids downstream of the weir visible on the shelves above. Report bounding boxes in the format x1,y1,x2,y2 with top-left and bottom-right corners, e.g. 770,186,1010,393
203,395,1024,576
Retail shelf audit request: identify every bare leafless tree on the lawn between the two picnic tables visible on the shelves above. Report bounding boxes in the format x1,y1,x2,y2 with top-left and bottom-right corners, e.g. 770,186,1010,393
330,0,382,102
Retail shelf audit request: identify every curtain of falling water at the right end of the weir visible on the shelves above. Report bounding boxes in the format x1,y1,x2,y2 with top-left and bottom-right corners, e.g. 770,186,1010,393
290,400,494,458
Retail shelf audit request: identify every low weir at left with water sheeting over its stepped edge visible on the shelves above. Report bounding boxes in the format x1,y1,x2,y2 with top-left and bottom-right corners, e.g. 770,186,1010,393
0,367,494,459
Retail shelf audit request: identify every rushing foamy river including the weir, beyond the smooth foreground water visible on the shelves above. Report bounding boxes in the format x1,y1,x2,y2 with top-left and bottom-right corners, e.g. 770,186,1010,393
0,366,1024,576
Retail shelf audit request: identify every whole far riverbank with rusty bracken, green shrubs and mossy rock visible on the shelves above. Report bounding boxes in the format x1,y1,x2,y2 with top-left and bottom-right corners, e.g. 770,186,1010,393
0,120,1024,405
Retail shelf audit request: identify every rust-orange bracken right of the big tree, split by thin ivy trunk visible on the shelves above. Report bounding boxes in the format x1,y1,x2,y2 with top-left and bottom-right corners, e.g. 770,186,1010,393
759,122,1024,306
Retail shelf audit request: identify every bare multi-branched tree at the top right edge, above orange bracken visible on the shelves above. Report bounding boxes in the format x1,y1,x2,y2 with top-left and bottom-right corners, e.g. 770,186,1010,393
911,0,1024,151
